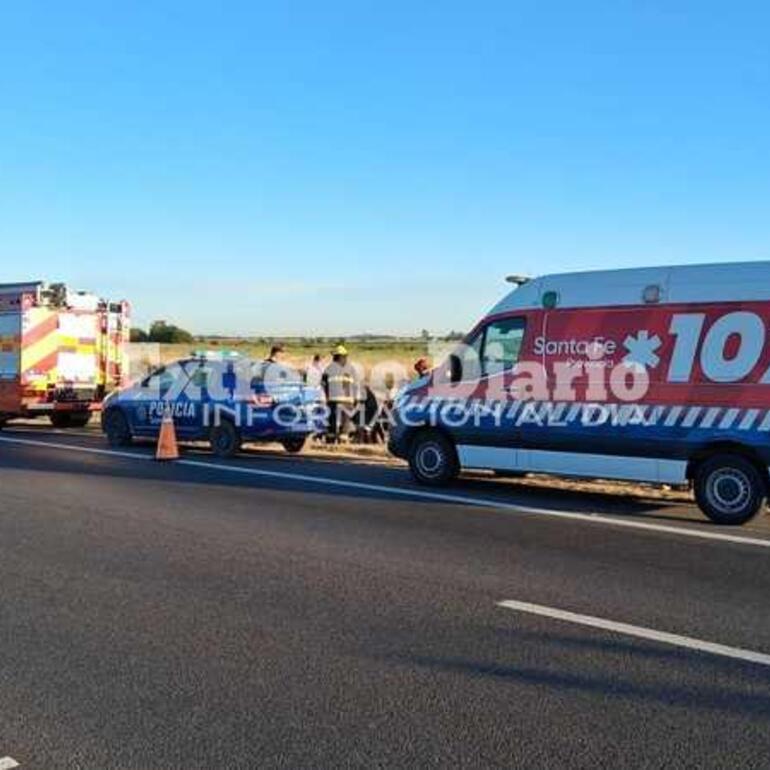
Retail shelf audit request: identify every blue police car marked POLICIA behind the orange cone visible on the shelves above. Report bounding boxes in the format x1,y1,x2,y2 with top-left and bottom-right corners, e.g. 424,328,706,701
102,354,326,457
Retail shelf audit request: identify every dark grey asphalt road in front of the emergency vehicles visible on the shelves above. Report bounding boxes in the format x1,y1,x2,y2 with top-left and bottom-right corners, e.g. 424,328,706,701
0,430,770,770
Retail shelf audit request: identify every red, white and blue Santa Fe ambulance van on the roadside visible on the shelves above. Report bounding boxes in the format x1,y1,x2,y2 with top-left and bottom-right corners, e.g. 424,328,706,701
390,262,770,524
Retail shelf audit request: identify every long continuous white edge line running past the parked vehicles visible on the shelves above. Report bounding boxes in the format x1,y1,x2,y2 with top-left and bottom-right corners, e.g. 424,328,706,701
0,436,770,548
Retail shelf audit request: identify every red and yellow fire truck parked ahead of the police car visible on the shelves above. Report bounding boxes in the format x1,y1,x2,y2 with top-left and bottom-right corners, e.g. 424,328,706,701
0,281,129,428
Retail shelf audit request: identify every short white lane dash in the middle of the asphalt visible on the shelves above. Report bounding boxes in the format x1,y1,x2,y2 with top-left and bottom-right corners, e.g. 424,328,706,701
498,601,770,666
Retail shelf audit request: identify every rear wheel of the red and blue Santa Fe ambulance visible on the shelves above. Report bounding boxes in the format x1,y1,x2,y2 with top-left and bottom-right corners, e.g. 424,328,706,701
694,454,767,525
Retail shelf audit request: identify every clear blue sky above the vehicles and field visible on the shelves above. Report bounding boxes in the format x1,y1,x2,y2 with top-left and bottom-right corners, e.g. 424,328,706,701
0,0,770,334
